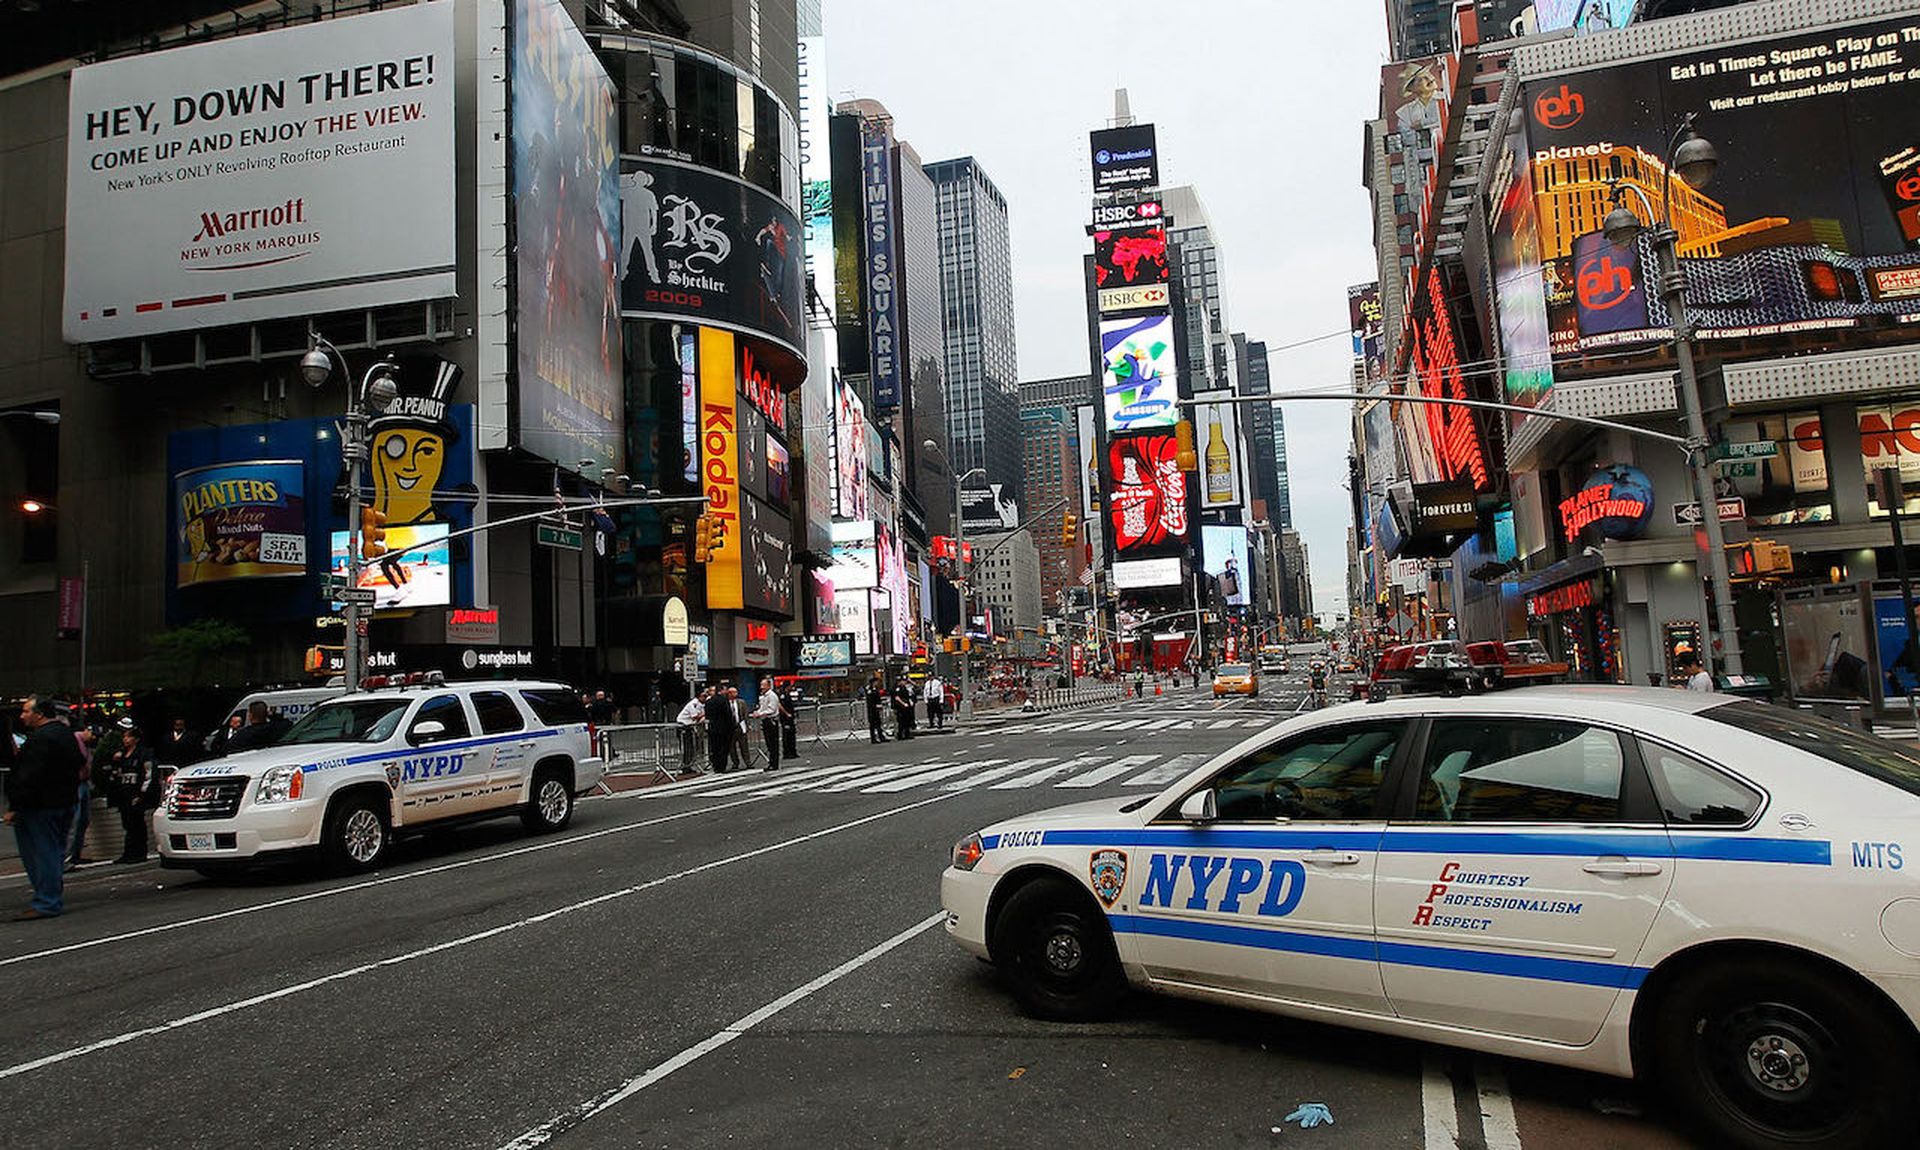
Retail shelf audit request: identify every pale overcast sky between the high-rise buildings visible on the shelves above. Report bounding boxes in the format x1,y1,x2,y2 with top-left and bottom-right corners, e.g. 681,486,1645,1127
826,0,1386,612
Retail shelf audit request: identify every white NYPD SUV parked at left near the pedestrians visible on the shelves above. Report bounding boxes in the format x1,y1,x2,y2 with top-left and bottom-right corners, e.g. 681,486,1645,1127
154,682,605,874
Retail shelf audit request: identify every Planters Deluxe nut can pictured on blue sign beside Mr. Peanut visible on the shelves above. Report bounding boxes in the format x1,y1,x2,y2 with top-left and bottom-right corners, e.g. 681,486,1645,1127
173,459,307,587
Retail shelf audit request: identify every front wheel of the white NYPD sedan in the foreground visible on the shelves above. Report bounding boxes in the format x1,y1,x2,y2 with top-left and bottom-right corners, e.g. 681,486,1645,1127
993,877,1127,1021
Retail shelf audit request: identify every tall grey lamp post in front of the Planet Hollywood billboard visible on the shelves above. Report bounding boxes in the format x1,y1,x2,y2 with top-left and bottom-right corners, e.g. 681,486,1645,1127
1601,111,1743,676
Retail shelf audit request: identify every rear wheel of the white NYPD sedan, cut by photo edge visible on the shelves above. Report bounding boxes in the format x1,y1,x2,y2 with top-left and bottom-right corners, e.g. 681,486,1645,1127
1644,958,1920,1150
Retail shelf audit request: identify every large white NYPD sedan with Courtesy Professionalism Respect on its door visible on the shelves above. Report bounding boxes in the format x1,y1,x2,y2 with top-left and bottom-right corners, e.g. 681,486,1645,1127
941,687,1920,1146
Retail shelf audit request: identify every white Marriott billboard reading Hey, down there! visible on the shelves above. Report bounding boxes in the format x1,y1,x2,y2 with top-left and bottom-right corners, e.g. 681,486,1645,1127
61,4,455,344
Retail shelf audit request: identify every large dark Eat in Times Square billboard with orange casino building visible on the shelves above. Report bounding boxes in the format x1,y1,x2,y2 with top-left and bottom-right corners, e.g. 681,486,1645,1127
1521,19,1920,365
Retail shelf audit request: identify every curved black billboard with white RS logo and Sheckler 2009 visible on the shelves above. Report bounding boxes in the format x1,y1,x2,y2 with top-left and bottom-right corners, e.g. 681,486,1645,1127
616,156,806,362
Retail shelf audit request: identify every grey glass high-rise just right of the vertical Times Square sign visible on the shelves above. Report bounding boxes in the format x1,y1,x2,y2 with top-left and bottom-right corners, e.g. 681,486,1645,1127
925,156,1021,530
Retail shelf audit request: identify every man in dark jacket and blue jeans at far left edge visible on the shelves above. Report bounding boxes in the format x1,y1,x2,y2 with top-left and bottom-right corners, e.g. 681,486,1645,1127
6,695,83,922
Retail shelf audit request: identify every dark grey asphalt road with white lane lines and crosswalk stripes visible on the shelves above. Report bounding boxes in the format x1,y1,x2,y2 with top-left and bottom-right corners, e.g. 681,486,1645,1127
0,674,1682,1150
